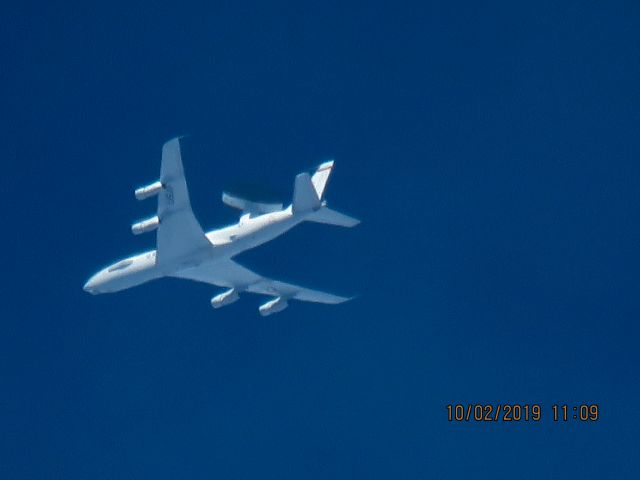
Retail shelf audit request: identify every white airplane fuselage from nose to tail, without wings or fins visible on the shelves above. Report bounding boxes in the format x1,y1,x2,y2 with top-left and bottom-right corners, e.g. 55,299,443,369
84,206,307,294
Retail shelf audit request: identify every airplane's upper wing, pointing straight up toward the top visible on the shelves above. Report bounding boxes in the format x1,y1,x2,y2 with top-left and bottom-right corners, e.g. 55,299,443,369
156,138,211,264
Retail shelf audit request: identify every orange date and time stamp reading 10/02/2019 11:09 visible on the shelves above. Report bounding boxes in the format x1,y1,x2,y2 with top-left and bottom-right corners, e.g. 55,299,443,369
447,403,600,422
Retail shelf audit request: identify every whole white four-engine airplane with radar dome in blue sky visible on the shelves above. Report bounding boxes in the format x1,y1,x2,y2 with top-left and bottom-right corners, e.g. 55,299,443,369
84,137,360,316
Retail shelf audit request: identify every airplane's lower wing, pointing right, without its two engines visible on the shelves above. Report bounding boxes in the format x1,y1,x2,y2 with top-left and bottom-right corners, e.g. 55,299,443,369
176,260,350,304
